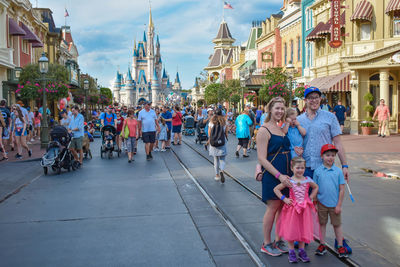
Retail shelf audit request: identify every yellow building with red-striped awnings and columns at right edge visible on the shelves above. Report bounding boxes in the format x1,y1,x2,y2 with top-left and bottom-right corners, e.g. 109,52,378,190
305,0,400,134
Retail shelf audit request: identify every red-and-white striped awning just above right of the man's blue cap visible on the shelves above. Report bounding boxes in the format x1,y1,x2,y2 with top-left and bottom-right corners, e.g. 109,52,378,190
309,72,351,92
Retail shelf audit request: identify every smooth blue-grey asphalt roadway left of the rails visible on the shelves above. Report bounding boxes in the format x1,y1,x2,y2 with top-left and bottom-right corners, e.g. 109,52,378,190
0,140,219,266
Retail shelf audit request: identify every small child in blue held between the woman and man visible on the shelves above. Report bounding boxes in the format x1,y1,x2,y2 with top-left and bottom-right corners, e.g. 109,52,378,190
283,108,307,158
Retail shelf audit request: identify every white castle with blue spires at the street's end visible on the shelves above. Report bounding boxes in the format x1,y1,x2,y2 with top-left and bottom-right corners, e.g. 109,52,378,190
111,8,182,106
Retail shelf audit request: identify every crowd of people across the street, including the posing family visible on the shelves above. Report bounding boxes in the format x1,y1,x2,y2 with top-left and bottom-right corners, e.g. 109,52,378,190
0,90,356,263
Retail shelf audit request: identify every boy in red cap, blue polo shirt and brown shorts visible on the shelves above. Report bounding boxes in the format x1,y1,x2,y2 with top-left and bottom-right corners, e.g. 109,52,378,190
313,144,348,257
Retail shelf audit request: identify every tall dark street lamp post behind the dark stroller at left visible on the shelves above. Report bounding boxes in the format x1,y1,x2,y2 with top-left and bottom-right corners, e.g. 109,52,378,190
39,52,49,148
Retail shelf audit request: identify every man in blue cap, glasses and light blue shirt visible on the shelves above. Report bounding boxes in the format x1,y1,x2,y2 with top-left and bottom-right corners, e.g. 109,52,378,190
297,87,349,181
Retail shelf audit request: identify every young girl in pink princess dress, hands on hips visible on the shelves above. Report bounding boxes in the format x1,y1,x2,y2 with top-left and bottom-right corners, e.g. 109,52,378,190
274,157,318,263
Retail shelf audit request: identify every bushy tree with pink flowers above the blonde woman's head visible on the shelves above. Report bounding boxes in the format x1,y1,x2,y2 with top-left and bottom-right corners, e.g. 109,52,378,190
259,67,290,103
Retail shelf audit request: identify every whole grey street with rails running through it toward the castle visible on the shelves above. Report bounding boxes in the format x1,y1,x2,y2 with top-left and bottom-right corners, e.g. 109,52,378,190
0,136,400,266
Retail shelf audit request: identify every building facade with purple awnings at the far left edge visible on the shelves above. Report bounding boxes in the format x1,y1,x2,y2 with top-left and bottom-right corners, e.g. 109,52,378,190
0,0,47,104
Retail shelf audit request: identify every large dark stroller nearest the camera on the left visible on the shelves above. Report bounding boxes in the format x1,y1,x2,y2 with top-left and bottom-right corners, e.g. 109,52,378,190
40,126,78,175
